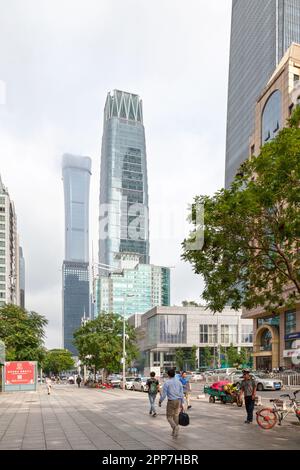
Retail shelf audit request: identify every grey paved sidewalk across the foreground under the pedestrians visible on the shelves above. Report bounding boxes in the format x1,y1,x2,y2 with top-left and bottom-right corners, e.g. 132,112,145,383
0,385,300,450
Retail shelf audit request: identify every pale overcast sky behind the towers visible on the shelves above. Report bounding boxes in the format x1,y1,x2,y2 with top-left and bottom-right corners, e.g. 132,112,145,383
0,0,231,347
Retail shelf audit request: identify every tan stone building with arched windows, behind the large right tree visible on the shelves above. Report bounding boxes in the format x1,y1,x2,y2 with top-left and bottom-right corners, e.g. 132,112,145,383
243,44,300,370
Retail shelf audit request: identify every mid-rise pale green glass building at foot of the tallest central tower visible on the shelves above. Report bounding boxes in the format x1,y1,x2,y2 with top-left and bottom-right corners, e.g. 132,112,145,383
96,253,170,318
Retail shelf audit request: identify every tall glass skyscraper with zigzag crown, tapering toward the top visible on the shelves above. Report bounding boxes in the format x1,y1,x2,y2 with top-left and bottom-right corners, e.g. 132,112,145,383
99,90,149,272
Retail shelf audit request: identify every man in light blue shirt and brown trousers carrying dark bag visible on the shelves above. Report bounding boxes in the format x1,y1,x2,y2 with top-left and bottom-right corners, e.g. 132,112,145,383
159,369,184,437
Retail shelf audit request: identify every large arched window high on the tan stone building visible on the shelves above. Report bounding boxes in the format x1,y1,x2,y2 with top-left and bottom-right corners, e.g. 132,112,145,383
261,90,281,145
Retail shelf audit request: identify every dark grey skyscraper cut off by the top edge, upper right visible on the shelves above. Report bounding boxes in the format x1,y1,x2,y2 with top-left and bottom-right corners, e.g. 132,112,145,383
225,0,300,187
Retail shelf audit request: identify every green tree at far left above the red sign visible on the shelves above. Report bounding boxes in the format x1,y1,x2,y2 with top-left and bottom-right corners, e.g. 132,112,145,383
0,305,48,363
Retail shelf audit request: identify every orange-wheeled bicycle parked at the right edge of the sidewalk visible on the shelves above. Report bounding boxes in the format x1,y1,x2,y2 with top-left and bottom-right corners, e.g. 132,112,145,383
256,390,300,429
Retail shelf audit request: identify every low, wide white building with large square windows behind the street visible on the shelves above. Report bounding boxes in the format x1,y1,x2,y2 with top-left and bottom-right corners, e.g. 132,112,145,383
129,307,253,370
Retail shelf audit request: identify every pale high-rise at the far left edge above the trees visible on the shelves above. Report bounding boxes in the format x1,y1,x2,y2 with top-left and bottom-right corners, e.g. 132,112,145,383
0,177,20,307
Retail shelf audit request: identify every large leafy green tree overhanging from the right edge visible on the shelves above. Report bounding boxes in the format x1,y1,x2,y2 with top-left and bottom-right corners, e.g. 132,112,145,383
183,107,300,312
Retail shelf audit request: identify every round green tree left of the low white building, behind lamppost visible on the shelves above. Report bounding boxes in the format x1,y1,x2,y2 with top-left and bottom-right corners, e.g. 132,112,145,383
74,313,138,376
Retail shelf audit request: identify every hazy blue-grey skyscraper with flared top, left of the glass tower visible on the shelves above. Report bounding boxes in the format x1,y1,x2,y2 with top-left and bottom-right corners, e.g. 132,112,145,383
62,154,91,354
